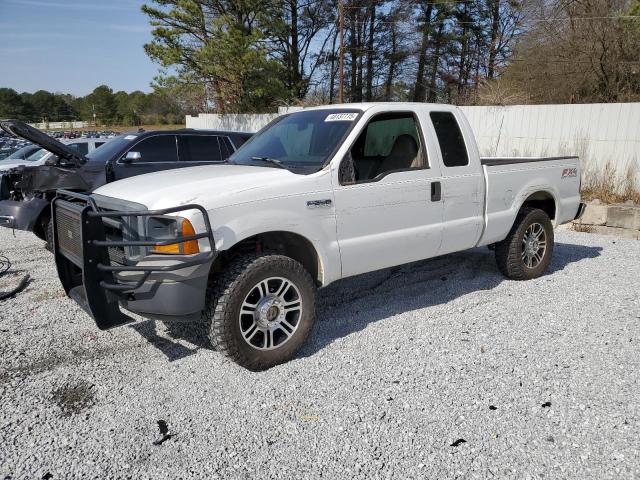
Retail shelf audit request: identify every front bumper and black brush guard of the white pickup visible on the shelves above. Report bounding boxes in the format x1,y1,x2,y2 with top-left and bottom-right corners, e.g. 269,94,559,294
52,190,216,330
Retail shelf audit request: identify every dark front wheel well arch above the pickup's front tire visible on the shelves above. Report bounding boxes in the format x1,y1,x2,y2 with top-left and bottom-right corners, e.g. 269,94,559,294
213,231,322,286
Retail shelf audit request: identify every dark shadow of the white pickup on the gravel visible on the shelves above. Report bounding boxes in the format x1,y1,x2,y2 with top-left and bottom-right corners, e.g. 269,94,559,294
300,243,602,357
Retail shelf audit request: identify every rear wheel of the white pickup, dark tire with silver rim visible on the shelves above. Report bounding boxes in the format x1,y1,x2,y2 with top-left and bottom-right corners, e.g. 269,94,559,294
495,208,554,280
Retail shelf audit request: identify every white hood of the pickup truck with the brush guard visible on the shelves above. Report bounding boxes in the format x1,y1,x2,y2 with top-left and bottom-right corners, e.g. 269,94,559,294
93,164,309,210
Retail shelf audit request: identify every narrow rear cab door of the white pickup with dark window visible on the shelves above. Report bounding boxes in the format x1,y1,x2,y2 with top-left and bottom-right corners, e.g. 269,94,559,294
429,111,484,255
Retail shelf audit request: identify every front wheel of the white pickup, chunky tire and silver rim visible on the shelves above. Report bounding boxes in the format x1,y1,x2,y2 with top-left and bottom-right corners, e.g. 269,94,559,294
203,254,316,370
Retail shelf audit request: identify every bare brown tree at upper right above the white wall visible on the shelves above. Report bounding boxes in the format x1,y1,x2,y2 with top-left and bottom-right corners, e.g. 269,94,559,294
482,0,640,103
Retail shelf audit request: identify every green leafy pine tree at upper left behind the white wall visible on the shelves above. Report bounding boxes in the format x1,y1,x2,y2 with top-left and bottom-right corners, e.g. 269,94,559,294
142,0,287,113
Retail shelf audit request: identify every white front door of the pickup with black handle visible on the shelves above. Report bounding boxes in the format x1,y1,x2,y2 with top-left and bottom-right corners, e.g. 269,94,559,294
334,112,442,277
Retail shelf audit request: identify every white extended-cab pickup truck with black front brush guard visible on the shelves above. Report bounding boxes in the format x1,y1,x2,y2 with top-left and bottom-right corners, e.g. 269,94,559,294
53,103,583,369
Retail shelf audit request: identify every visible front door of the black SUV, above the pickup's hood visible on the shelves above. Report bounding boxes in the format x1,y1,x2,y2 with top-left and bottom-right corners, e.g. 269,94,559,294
113,134,180,180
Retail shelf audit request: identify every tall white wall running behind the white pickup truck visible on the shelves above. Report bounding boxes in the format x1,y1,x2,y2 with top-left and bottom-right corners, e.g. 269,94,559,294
187,103,640,185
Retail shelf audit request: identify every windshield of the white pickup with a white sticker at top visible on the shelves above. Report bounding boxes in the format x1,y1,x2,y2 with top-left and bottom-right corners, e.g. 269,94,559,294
229,109,360,174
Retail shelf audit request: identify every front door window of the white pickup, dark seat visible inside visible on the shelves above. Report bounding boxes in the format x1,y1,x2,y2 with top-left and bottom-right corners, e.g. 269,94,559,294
341,113,426,184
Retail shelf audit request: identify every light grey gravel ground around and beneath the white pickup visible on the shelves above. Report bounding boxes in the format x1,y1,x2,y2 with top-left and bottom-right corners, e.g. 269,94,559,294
0,229,640,479
